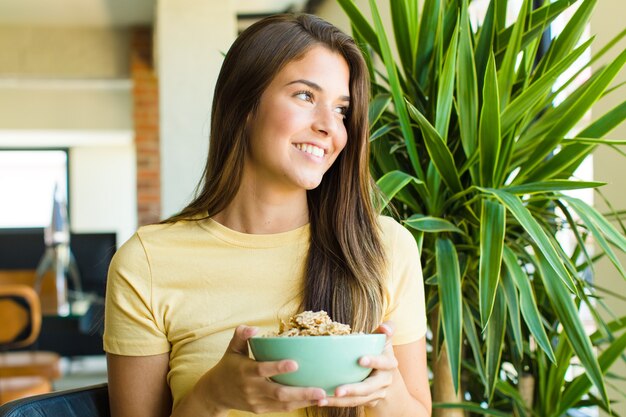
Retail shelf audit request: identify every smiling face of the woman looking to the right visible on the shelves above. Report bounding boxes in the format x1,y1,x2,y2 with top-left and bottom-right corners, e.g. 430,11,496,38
245,46,350,192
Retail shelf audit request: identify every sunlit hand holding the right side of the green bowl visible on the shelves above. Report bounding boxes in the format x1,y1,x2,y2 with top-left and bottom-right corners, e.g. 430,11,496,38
317,322,398,407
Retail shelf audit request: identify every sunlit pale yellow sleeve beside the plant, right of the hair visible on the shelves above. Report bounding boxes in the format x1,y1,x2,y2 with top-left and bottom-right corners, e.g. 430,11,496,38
385,218,427,345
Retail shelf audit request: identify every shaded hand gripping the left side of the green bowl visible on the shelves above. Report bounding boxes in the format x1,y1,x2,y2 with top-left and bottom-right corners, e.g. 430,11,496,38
193,326,326,416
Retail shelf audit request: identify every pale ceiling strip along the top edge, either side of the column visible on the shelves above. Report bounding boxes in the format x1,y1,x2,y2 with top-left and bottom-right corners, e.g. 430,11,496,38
0,0,308,27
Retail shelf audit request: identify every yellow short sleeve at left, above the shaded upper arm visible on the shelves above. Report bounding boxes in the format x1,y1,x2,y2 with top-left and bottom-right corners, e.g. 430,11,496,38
104,234,170,356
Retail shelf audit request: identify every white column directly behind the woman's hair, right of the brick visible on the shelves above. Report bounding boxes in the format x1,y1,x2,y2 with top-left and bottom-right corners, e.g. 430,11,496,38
156,0,237,217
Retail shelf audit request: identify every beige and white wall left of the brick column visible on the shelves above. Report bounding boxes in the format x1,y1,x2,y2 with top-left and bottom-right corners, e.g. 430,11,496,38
0,26,137,244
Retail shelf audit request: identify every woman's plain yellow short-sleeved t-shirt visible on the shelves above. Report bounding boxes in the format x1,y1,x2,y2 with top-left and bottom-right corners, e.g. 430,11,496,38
104,217,426,417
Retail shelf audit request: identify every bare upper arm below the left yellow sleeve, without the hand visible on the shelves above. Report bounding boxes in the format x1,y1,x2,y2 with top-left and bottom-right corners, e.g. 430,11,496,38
107,353,172,417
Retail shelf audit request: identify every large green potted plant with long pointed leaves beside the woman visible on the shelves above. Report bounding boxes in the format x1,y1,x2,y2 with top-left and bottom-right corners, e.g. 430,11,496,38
338,0,626,417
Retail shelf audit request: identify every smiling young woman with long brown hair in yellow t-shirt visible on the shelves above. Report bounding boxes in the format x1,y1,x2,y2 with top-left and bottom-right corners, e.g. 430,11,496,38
104,15,431,417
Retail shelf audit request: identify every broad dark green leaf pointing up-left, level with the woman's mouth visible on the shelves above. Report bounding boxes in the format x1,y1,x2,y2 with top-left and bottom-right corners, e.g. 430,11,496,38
406,101,463,193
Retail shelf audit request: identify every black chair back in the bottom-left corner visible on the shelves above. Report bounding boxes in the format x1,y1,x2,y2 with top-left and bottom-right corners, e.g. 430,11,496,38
0,384,111,417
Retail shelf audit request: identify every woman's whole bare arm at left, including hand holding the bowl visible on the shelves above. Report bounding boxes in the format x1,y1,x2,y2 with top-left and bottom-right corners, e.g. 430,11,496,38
107,326,326,417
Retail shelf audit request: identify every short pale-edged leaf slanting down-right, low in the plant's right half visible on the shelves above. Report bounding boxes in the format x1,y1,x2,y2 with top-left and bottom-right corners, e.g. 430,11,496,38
503,246,556,363
